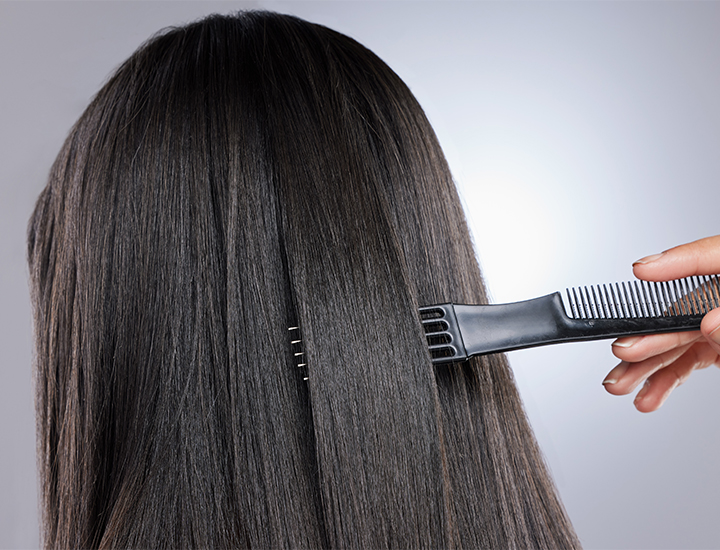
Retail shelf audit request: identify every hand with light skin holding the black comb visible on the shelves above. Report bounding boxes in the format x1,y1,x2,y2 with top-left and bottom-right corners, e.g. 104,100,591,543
603,235,720,412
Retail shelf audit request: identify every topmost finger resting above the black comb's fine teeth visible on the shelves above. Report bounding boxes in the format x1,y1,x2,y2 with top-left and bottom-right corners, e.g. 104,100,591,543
633,235,720,281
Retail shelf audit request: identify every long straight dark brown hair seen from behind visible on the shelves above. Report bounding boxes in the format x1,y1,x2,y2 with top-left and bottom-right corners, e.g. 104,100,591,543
28,12,578,548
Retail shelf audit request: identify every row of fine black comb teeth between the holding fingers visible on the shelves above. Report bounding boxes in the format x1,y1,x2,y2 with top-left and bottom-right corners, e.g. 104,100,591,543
563,275,720,319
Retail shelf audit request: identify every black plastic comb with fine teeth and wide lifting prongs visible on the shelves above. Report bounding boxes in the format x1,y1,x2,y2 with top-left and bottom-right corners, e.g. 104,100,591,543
420,275,720,364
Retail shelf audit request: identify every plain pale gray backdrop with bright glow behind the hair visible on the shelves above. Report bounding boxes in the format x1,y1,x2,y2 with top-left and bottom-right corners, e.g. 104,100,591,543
0,1,720,548
